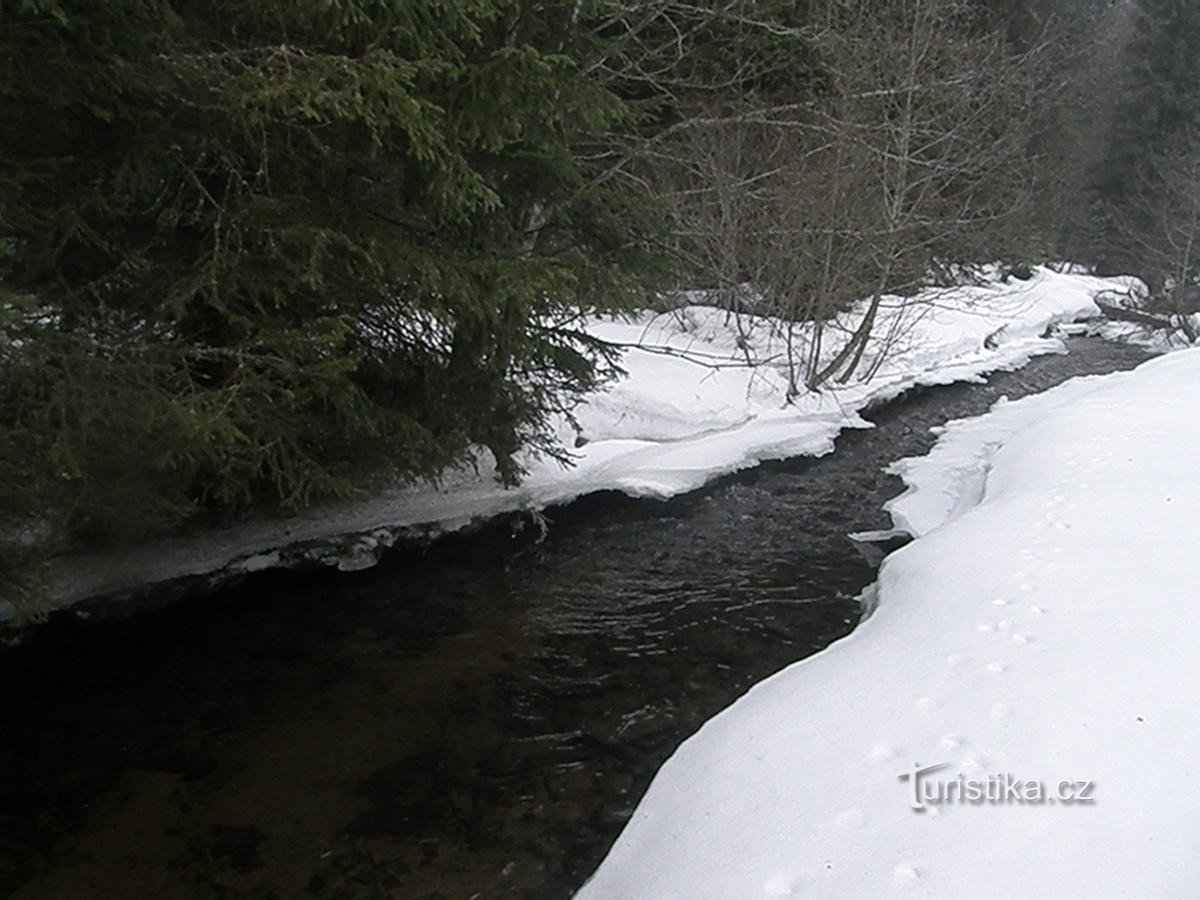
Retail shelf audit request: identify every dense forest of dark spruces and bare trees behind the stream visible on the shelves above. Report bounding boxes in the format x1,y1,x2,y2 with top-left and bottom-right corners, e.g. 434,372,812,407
0,0,1200,607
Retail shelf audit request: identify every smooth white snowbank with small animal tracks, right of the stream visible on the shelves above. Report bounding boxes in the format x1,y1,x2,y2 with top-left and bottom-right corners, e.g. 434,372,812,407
578,349,1200,900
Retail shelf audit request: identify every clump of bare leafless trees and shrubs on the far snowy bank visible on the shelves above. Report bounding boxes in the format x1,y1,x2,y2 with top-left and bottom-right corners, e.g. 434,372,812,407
626,0,1040,395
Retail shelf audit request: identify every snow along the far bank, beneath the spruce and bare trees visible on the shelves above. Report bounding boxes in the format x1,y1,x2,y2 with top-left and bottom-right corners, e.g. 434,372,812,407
30,269,1130,620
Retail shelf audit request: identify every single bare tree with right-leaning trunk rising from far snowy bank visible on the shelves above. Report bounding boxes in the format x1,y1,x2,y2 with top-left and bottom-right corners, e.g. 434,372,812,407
815,0,1037,384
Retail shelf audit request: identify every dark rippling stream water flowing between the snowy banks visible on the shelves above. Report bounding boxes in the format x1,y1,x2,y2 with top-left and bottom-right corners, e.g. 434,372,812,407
0,338,1145,900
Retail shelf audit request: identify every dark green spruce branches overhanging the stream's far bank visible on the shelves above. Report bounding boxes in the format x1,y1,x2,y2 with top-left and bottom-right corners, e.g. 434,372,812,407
0,0,656,585
